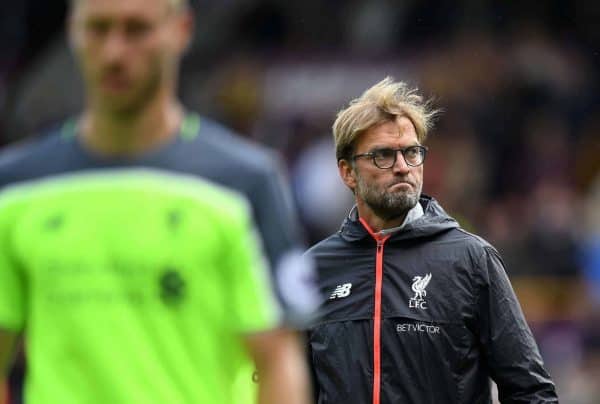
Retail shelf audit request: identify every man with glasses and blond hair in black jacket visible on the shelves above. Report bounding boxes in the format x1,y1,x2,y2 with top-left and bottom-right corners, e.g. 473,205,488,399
307,78,558,404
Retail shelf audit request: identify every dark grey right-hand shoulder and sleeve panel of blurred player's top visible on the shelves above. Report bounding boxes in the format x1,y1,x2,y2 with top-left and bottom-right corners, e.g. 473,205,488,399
173,118,300,256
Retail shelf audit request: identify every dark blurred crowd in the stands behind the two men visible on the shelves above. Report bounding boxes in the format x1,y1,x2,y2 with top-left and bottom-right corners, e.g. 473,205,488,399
0,0,600,404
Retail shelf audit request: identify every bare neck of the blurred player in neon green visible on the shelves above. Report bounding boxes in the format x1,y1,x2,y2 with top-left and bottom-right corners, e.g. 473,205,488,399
79,101,183,157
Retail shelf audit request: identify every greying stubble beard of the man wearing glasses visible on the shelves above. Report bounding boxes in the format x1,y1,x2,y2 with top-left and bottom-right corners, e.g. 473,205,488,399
355,173,423,220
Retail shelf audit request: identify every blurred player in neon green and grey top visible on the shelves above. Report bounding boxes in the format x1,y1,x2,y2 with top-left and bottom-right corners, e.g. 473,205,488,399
0,0,314,404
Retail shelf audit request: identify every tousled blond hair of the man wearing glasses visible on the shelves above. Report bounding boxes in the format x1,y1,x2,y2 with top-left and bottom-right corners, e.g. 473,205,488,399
333,77,439,161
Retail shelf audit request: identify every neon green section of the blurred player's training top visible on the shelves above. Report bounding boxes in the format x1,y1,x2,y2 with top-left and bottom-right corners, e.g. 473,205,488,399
0,169,279,404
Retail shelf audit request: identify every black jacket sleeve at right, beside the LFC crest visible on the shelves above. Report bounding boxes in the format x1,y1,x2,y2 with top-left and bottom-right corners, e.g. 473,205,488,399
477,247,558,404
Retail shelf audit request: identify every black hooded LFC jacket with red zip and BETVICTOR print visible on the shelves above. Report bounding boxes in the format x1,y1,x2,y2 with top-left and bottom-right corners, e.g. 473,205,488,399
307,196,558,404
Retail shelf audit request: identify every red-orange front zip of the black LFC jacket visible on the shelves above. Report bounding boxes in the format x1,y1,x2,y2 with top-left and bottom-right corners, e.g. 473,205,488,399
360,218,391,404
